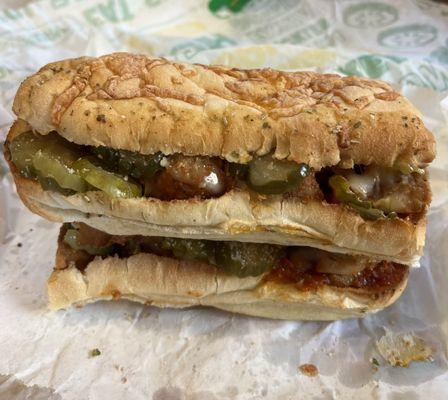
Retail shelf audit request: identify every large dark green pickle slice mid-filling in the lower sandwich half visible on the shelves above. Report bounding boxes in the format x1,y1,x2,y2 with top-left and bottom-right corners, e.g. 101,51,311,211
215,242,284,278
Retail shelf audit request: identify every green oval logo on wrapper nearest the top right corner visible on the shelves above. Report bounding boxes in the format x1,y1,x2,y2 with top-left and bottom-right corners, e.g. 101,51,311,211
378,24,437,49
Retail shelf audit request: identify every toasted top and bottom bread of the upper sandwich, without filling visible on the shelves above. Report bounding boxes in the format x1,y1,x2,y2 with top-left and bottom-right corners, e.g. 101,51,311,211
5,53,435,265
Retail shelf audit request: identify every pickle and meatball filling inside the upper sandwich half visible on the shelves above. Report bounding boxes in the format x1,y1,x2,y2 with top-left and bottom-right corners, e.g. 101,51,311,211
7,131,430,219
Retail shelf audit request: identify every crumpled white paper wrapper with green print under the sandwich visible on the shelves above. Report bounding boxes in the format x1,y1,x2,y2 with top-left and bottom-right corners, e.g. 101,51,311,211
0,0,448,400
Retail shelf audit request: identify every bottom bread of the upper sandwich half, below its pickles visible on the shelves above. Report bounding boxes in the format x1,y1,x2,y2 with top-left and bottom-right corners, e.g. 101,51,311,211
5,120,426,265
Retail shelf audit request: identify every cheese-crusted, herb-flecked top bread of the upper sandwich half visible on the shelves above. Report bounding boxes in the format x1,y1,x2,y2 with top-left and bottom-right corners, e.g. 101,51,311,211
13,53,435,169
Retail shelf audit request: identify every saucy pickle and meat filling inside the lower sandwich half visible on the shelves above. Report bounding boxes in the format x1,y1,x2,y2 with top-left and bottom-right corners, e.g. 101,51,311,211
60,223,409,293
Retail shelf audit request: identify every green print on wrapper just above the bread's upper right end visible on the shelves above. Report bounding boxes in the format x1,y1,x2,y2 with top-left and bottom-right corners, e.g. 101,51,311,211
339,55,405,79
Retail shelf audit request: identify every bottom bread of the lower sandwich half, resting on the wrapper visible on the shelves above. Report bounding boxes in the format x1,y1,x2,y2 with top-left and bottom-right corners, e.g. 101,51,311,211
48,233,407,320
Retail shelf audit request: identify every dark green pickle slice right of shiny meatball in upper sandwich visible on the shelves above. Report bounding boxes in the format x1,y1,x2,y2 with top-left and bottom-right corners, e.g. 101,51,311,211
247,154,310,194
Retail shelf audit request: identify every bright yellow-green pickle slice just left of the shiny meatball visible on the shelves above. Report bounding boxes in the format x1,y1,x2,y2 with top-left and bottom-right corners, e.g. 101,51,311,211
73,158,142,198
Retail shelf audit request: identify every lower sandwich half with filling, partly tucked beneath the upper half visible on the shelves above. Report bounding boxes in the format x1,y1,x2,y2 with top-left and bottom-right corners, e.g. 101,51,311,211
48,223,409,320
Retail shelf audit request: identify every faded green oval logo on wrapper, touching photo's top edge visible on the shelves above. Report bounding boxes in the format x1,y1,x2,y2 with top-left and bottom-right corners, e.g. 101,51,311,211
343,2,398,29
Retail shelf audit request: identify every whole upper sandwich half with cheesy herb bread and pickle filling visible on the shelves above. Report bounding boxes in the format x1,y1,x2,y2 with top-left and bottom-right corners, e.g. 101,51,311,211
5,53,435,268
